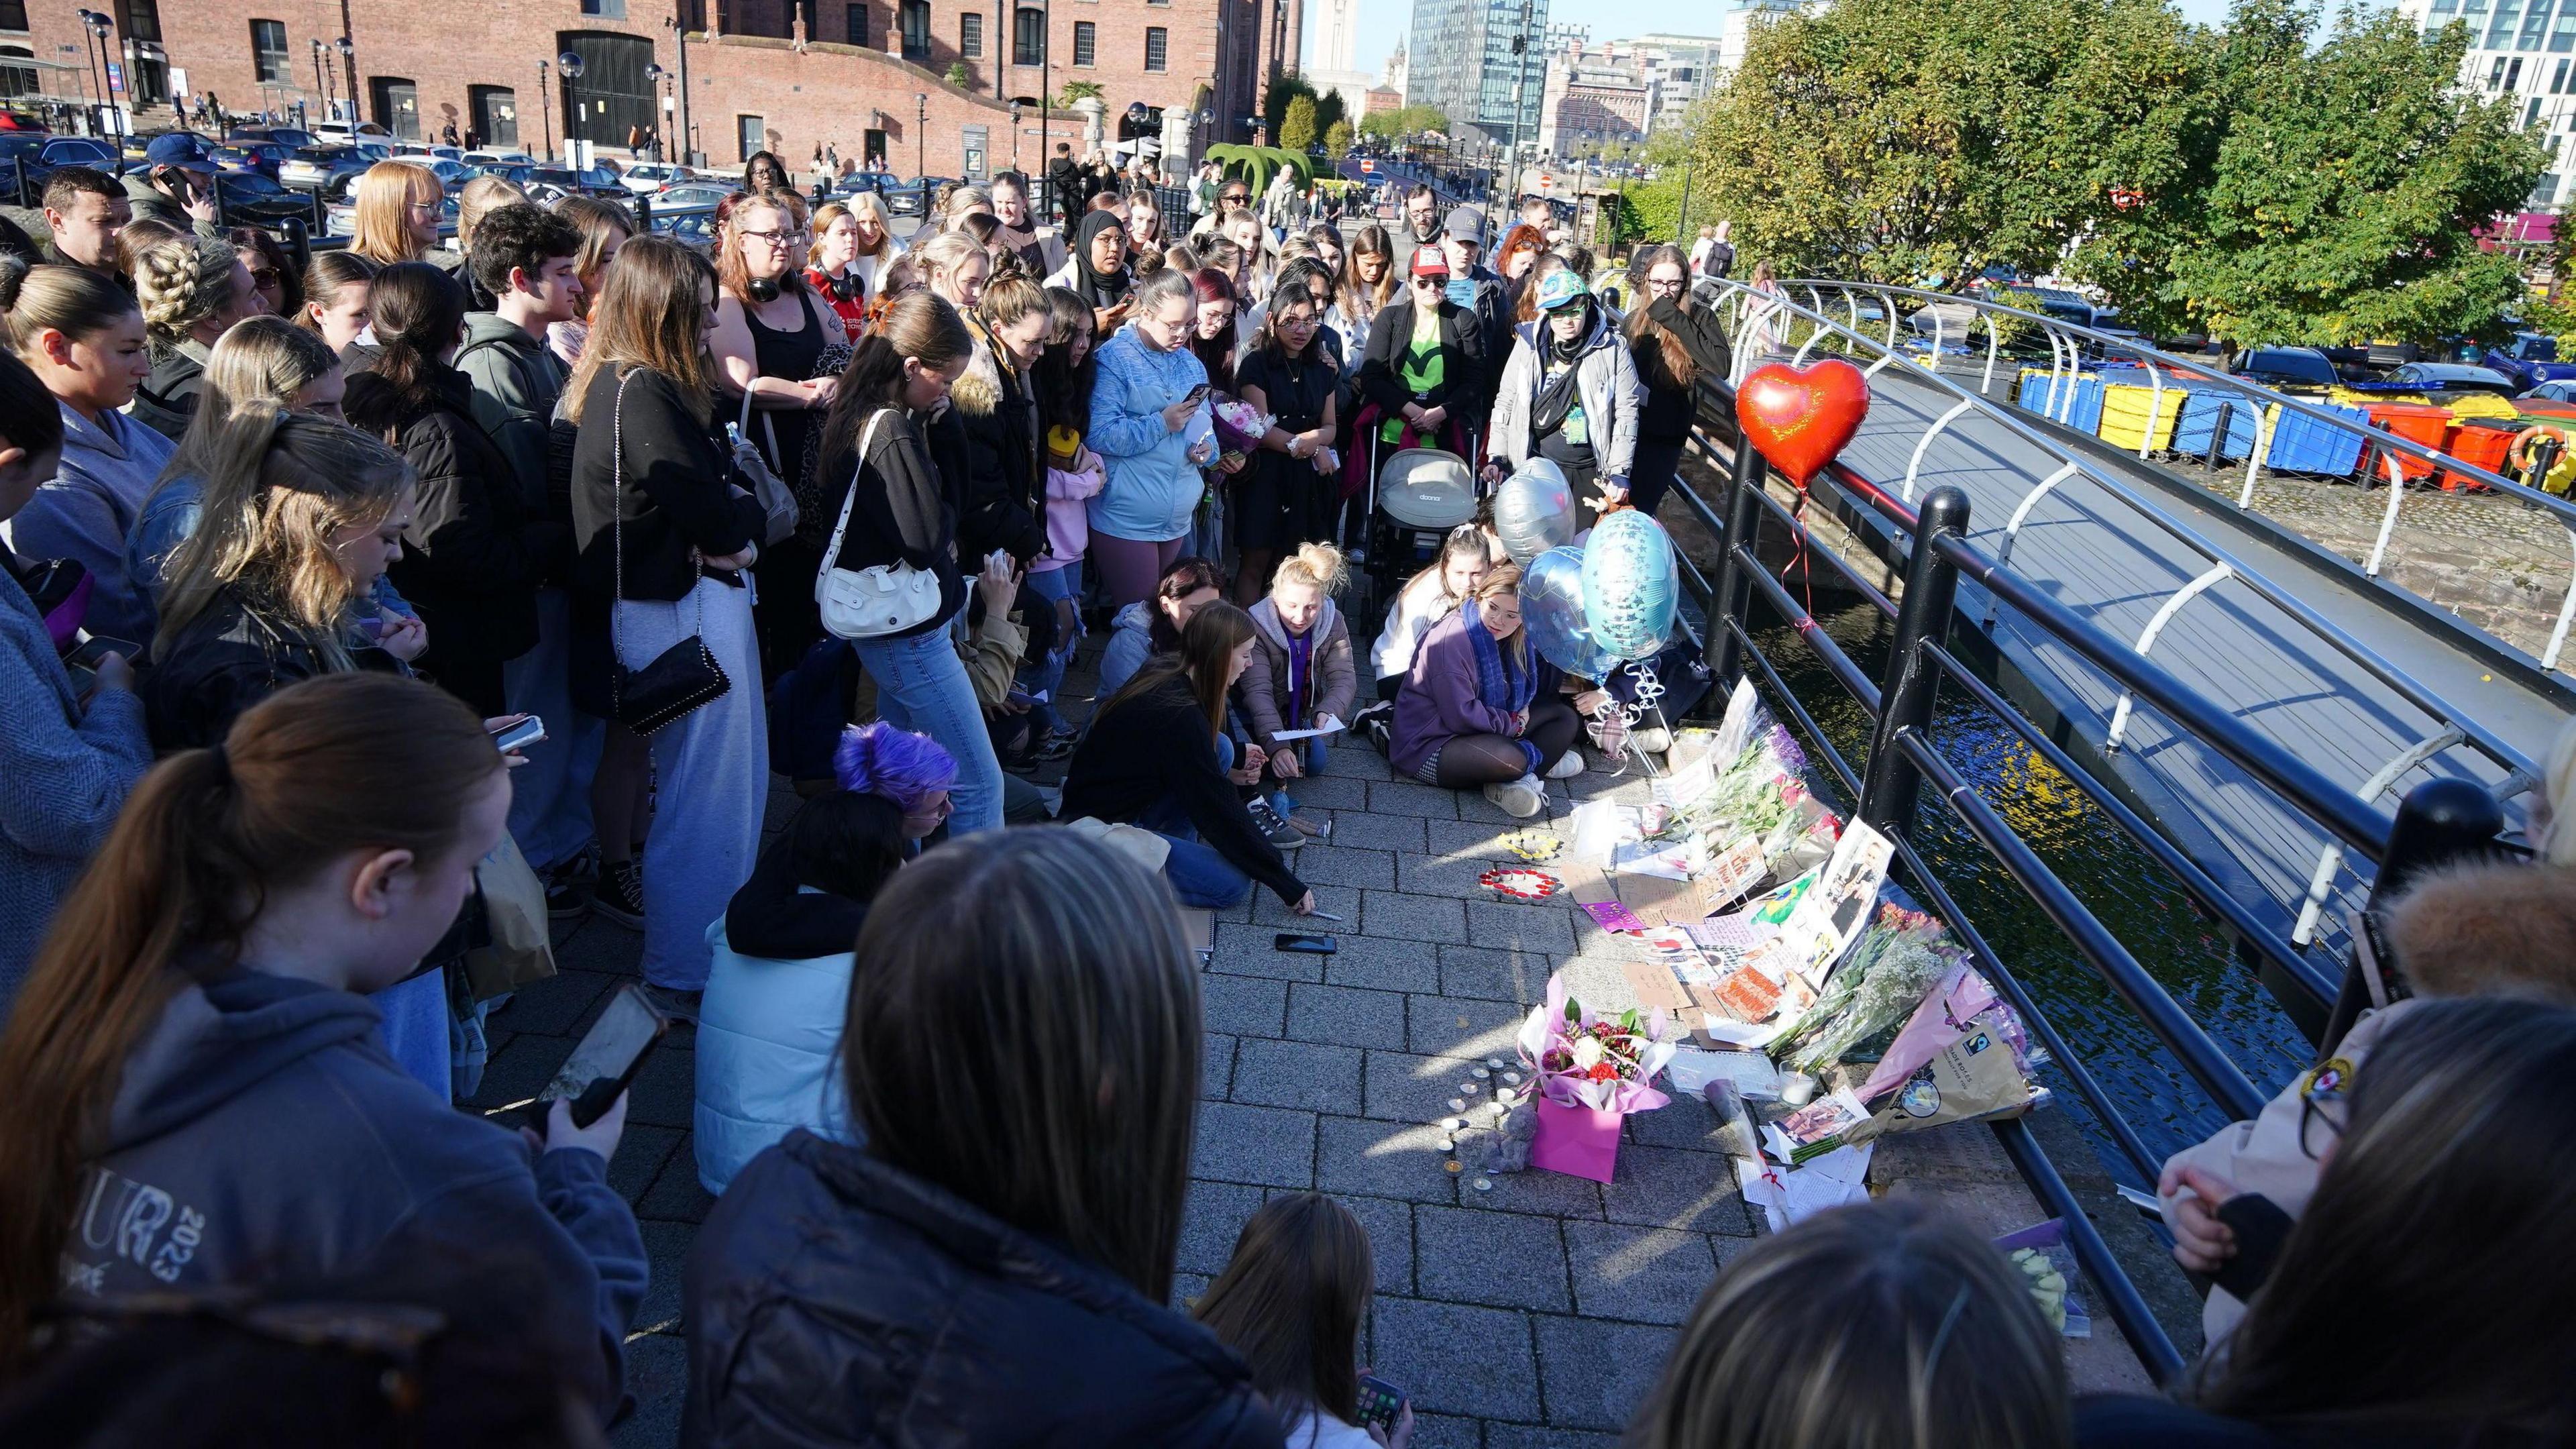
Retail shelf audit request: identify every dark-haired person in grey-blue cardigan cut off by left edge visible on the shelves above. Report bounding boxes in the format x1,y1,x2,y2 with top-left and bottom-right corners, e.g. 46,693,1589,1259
0,354,152,1016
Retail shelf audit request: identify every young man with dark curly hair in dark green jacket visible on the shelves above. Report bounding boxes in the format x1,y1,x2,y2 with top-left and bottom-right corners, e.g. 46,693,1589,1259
456,201,600,920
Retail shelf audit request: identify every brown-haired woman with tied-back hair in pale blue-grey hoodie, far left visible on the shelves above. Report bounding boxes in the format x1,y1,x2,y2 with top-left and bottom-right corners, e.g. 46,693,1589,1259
0,266,172,645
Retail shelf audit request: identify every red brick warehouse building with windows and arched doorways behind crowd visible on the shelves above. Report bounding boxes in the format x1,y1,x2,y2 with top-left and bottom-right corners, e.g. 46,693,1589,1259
0,0,1301,175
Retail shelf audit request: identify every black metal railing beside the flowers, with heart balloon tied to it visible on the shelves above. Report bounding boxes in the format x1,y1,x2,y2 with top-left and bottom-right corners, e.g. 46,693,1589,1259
1672,368,2502,1382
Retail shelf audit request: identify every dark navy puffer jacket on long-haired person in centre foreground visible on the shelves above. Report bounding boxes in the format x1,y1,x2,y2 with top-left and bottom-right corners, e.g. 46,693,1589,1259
680,1132,1280,1449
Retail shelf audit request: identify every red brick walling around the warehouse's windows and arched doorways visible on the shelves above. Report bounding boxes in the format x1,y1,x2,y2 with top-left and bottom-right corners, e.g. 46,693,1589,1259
0,0,1256,175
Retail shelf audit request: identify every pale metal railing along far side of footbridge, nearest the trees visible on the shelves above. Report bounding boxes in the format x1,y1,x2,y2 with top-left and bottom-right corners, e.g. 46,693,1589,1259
1782,278,2576,670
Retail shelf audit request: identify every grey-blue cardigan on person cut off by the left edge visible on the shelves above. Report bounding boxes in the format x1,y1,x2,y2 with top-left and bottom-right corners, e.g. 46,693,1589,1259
0,551,152,1018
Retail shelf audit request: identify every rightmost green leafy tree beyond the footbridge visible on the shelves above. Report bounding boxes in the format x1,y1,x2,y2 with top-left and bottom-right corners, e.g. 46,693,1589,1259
2074,0,2548,345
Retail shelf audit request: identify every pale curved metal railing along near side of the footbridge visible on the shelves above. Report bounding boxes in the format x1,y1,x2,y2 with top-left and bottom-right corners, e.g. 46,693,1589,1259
1713,281,2534,947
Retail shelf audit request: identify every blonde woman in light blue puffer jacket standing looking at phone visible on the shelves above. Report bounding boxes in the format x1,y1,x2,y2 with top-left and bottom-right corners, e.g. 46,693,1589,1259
1089,271,1216,608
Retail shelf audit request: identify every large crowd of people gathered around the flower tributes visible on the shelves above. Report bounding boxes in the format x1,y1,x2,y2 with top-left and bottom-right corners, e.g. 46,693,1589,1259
0,144,2576,1449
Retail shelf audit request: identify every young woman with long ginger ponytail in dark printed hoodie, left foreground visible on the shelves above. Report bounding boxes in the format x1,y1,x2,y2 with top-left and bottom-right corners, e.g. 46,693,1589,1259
0,676,647,1418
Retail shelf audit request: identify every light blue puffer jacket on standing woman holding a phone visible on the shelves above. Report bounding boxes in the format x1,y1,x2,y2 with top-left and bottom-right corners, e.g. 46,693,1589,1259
1085,327,1216,544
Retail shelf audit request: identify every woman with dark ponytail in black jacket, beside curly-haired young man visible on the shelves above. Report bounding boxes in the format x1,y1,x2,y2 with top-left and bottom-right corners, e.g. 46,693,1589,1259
345,260,570,716
